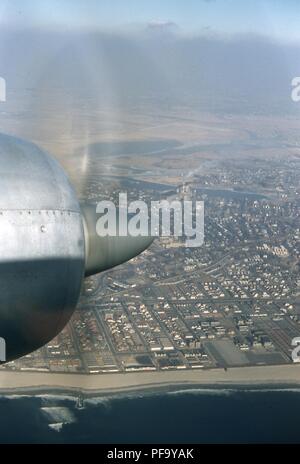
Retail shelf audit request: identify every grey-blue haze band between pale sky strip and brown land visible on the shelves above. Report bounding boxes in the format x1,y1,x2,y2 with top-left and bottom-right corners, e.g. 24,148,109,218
0,23,300,115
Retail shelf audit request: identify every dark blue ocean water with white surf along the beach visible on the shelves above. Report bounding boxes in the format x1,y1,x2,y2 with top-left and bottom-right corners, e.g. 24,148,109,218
0,388,300,444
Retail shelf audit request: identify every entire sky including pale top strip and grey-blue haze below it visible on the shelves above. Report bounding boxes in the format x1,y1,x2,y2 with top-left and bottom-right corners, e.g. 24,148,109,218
0,0,300,123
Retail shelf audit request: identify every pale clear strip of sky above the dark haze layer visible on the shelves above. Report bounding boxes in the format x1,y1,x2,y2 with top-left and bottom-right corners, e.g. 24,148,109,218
0,0,300,41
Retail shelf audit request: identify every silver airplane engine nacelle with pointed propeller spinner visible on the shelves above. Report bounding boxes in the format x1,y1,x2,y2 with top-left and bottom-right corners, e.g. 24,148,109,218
0,134,152,363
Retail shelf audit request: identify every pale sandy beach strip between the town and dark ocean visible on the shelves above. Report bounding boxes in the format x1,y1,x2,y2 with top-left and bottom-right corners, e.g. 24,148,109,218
0,364,300,397
